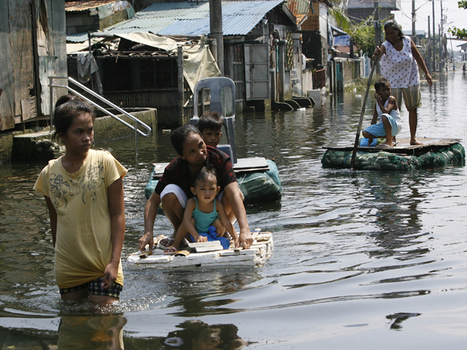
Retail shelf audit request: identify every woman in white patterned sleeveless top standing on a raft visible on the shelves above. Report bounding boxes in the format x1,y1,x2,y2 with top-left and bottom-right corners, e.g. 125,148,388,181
375,20,433,145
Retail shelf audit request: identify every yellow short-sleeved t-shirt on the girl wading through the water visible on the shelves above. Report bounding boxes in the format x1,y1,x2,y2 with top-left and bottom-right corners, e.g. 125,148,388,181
34,150,127,288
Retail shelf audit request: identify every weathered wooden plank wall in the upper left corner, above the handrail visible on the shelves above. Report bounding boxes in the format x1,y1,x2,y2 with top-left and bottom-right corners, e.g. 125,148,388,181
0,0,66,130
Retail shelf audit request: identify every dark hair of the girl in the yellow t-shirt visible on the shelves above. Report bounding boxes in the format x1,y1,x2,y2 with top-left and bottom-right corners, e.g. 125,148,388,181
53,95,94,140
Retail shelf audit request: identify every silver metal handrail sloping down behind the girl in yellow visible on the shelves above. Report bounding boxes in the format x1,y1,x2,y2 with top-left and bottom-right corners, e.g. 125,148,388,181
49,77,152,137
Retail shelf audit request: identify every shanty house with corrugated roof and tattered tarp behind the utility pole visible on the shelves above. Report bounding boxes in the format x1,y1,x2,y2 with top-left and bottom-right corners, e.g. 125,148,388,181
66,0,306,127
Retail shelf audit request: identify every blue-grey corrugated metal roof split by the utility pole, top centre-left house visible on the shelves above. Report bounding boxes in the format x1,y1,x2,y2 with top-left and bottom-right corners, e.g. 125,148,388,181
106,0,284,36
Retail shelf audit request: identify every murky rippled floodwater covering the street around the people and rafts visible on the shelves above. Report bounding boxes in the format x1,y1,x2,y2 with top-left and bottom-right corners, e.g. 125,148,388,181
0,71,467,349
